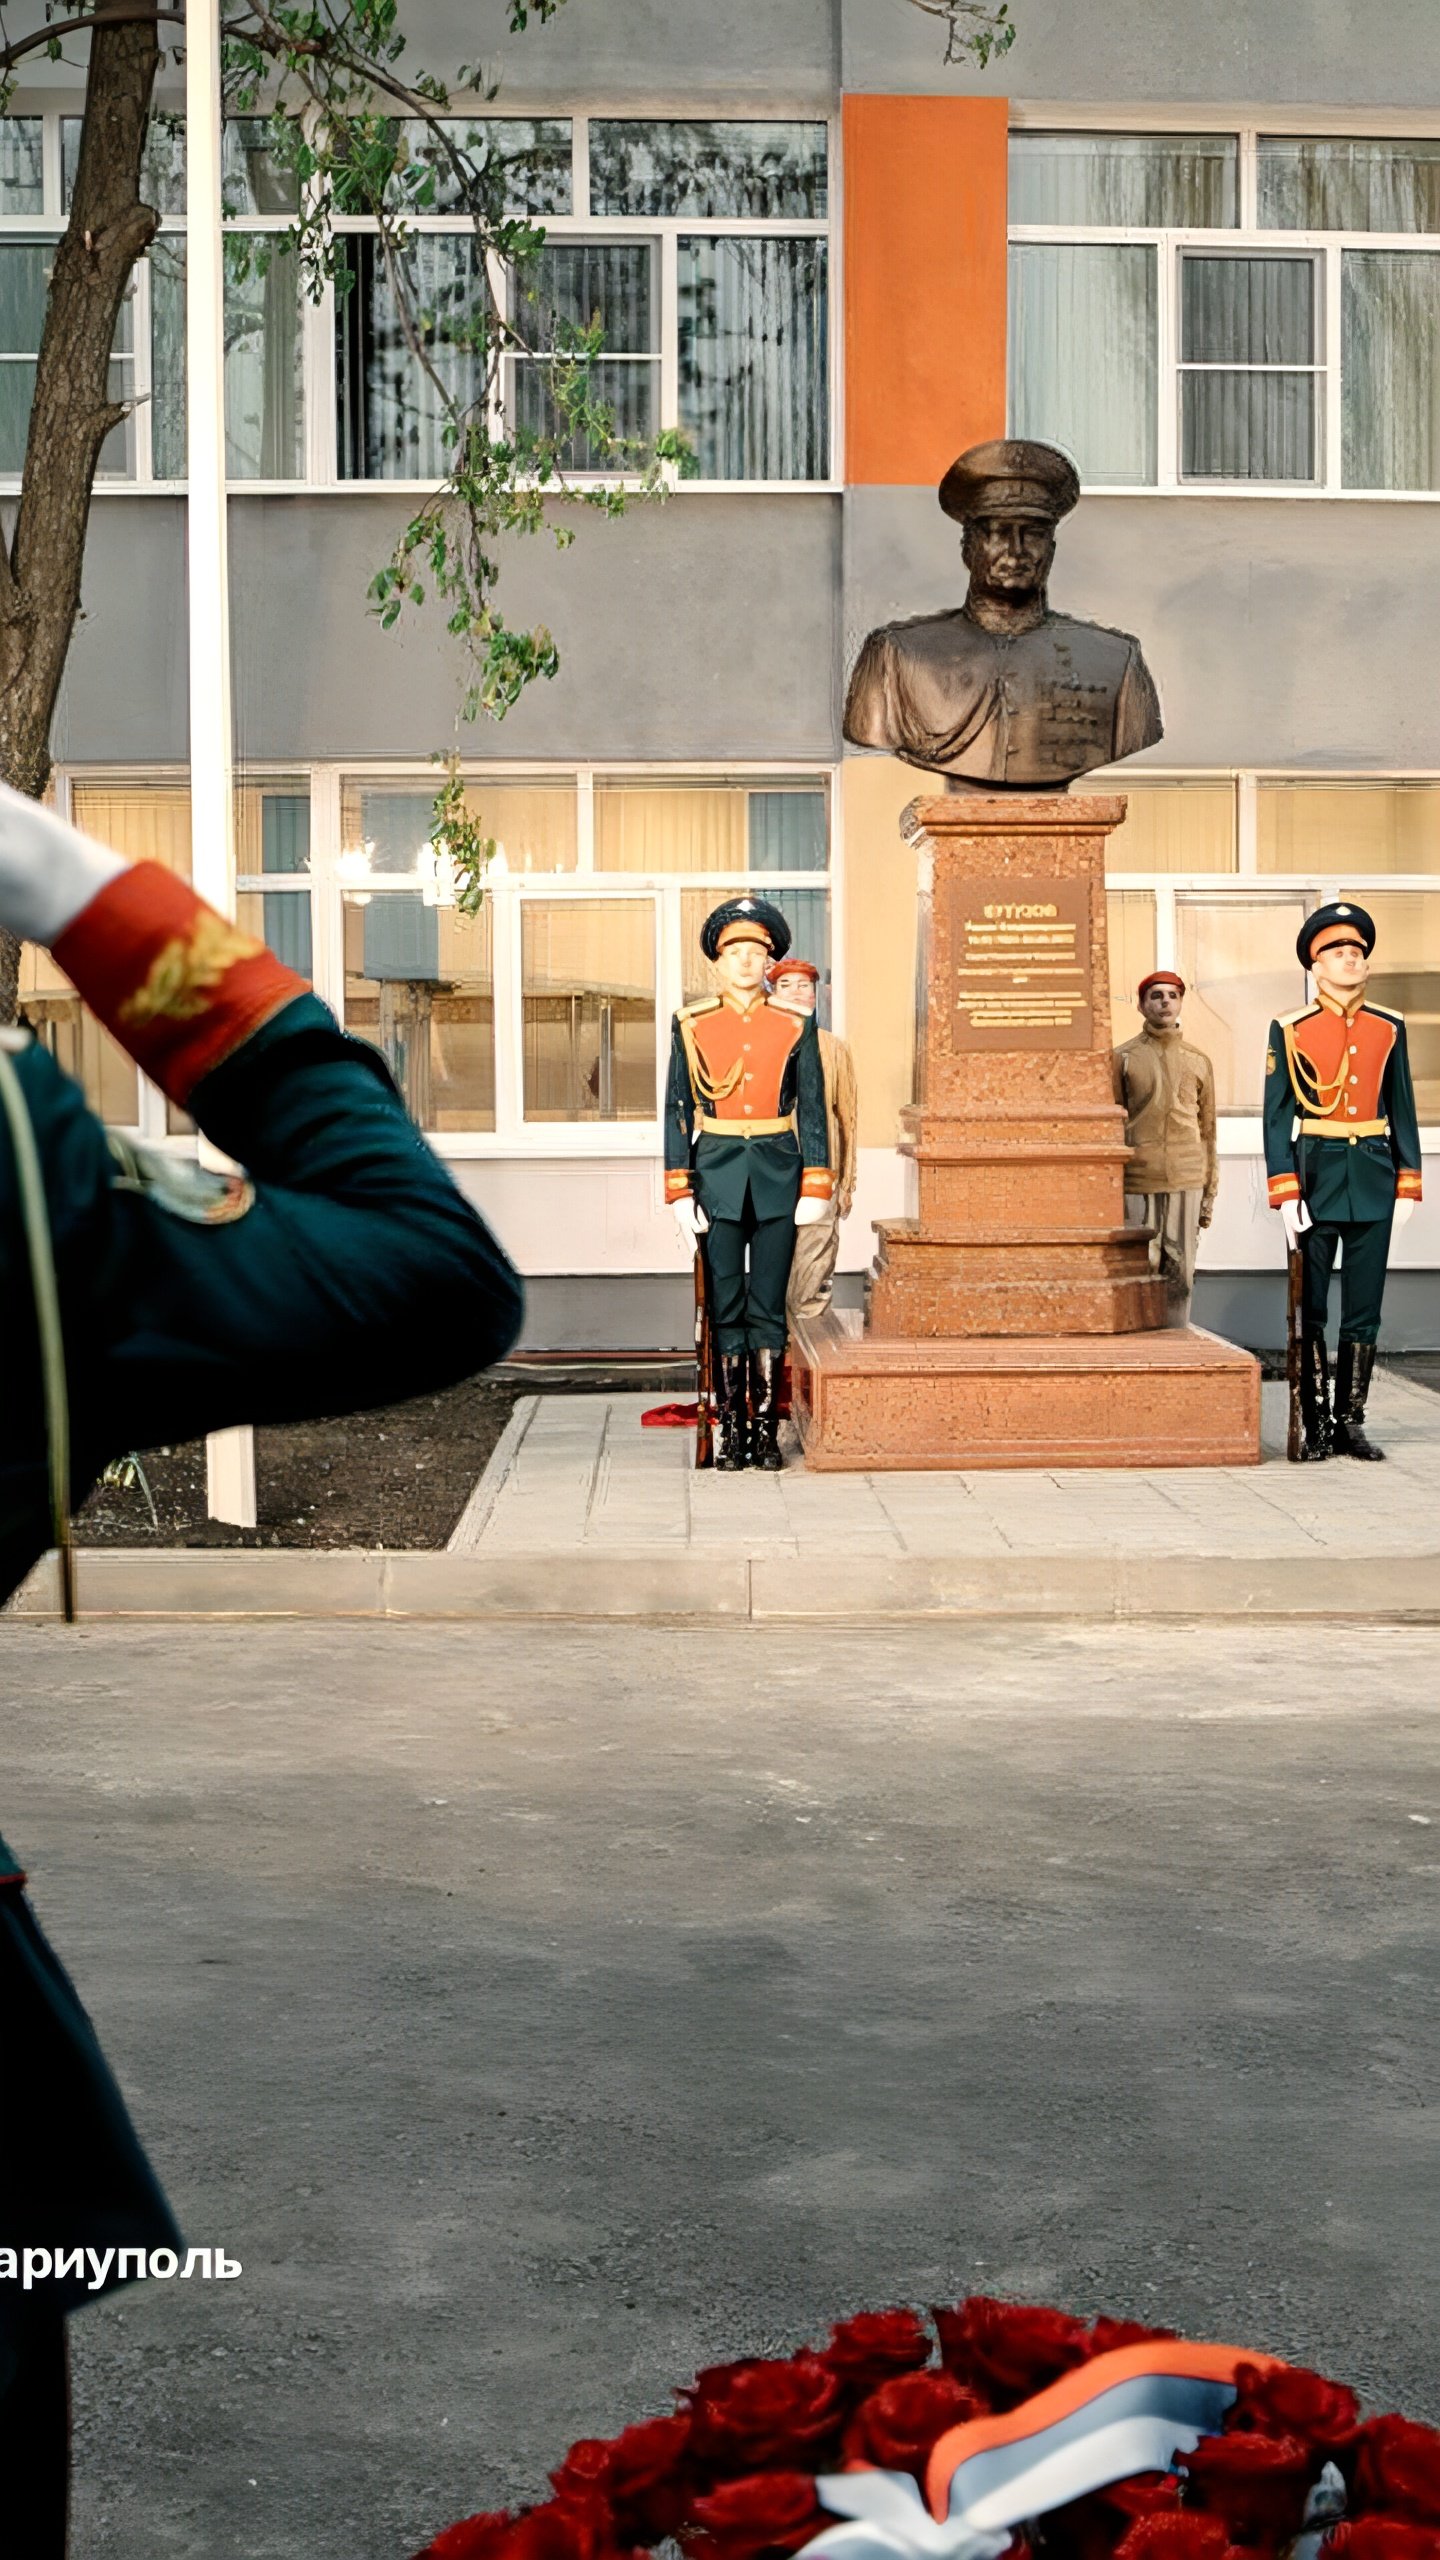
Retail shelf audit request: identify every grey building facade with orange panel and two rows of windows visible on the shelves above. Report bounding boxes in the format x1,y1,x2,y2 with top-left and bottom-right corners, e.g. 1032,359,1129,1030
11,0,1440,1349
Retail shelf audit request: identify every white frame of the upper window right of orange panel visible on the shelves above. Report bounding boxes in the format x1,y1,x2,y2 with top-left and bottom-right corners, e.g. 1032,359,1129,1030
1010,105,1440,507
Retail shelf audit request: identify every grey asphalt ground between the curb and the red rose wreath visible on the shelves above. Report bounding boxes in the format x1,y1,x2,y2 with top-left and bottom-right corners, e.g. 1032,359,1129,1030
0,1617,1440,2560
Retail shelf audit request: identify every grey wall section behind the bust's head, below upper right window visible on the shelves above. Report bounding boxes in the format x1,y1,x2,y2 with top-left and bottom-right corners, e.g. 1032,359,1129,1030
846,489,1440,771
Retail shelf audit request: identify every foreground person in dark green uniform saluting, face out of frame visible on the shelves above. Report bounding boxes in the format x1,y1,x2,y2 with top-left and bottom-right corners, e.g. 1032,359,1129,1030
0,786,523,2560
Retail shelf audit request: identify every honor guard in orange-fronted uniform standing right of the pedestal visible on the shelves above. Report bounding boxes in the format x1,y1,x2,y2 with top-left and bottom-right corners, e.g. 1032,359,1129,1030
1266,901,1420,1459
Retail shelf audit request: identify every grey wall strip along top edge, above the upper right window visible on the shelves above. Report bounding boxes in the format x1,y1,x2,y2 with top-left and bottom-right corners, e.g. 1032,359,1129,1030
840,0,1440,110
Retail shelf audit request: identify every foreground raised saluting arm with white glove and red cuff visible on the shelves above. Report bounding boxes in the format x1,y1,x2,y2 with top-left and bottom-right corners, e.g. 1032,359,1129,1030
0,786,523,1457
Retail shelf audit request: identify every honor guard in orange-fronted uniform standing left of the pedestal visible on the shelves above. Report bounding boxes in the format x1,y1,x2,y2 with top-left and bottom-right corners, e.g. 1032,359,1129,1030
666,899,833,1469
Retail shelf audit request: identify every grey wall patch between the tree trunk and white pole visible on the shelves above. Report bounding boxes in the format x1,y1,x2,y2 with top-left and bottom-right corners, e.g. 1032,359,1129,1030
51,497,190,765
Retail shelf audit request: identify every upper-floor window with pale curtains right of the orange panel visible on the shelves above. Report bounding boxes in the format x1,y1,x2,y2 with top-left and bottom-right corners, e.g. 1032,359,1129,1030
1010,131,1440,492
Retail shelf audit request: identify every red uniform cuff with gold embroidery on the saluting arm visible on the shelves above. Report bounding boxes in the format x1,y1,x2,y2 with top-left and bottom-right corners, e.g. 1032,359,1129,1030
54,863,310,1103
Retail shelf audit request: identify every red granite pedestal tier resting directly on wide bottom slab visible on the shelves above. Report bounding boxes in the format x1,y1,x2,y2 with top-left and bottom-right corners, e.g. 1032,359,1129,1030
866,1219,1166,1341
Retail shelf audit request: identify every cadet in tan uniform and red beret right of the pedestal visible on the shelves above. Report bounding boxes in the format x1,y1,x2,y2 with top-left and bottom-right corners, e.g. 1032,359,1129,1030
1115,968,1220,1324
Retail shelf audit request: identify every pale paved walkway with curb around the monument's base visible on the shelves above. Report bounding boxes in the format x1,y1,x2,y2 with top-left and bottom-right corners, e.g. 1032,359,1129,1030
15,1372,1440,1620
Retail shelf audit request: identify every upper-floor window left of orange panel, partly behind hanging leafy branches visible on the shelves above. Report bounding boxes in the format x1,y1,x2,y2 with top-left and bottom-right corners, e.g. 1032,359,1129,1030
336,118,830,484
